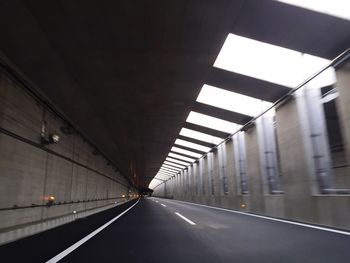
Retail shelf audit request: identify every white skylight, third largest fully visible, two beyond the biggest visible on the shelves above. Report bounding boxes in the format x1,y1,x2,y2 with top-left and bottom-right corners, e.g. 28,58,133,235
186,111,240,134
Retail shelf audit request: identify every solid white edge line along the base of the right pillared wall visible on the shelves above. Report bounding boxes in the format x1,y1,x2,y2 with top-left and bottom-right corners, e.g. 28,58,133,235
155,200,350,236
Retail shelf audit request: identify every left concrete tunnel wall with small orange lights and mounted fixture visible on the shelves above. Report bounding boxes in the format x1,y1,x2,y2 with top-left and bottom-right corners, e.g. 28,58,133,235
0,73,136,243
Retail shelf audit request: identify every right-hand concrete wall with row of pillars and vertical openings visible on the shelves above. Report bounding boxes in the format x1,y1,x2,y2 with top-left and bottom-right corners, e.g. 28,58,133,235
154,65,350,230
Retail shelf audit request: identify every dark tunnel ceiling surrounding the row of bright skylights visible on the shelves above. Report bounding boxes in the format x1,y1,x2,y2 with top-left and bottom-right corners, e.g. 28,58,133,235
0,0,350,190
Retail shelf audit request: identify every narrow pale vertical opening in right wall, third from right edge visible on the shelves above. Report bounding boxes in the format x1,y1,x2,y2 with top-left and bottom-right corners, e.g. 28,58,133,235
233,132,248,195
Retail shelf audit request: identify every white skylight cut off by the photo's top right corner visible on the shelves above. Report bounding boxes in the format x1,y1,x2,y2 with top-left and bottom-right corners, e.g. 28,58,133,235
277,0,350,20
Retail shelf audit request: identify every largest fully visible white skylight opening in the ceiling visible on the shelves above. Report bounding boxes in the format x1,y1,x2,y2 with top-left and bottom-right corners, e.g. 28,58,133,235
214,33,333,88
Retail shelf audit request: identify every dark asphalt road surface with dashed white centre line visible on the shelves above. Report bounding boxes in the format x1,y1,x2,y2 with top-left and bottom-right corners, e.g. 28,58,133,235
0,198,350,263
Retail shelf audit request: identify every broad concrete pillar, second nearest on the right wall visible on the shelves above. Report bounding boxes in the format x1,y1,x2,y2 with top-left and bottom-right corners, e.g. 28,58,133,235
276,92,317,222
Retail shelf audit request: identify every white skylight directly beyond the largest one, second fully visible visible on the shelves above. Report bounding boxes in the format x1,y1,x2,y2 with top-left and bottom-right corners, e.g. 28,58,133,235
197,84,272,117
